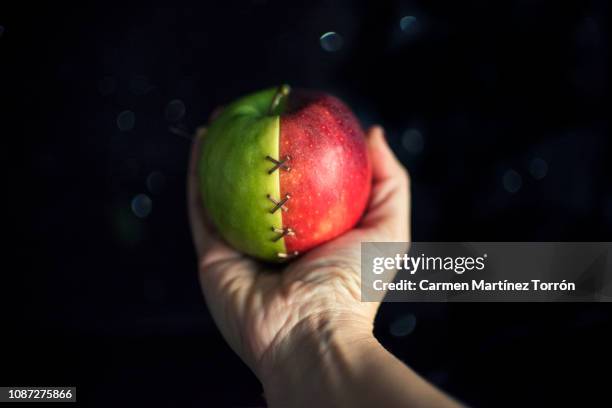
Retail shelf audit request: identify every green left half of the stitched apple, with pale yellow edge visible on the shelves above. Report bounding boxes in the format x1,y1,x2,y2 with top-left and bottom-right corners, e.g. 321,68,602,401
199,88,287,260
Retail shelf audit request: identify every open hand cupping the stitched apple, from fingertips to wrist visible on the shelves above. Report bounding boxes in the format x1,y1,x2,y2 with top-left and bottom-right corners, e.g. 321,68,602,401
188,127,410,387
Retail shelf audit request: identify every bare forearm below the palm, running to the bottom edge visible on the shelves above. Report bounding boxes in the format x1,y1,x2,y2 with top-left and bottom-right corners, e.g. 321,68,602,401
263,320,460,408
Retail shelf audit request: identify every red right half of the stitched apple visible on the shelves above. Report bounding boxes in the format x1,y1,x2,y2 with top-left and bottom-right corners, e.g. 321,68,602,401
280,90,372,253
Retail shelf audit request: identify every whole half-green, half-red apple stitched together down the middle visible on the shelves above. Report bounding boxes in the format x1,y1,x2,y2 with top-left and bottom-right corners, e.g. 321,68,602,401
198,85,372,262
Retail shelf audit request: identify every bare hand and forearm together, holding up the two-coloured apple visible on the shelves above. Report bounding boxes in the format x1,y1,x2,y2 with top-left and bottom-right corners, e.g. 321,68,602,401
188,126,461,408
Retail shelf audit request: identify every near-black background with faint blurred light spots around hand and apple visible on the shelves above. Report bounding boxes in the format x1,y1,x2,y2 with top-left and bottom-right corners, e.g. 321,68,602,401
0,0,612,407
